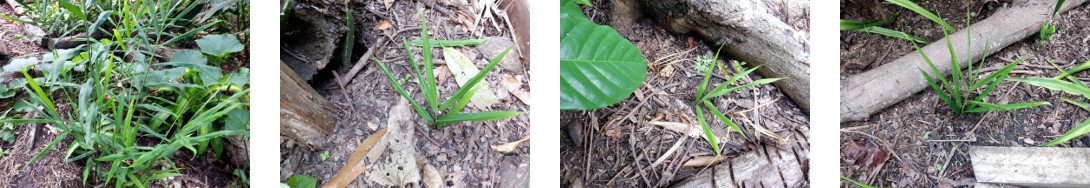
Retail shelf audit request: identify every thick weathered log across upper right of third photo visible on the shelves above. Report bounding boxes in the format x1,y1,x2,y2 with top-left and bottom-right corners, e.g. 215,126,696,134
620,0,810,114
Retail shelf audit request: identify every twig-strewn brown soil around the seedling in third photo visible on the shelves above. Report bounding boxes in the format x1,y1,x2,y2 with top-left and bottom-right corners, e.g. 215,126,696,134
560,1,810,187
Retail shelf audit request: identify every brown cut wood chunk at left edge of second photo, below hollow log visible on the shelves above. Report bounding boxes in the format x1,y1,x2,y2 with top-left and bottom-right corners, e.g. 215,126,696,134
280,61,338,149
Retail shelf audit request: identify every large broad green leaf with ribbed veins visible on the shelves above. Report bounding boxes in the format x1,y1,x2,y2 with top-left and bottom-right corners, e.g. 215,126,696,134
559,0,647,110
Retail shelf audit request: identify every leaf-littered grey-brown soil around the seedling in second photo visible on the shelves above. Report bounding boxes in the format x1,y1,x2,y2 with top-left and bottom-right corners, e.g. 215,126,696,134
280,1,533,187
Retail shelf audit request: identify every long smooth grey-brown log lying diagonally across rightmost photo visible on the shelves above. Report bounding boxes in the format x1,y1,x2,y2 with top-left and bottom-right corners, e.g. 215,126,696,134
840,0,1087,122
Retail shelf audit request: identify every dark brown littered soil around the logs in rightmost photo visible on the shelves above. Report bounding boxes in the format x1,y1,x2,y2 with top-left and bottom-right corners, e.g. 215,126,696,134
840,1,1090,187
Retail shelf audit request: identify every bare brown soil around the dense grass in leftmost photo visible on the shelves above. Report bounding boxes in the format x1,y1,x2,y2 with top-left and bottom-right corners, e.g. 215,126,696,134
0,1,250,187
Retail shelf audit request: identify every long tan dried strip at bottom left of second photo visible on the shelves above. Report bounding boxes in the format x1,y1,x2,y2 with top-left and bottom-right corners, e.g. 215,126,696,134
322,128,387,188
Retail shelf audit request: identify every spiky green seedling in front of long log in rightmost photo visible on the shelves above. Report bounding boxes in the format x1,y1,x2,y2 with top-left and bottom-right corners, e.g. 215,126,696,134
906,1,1052,114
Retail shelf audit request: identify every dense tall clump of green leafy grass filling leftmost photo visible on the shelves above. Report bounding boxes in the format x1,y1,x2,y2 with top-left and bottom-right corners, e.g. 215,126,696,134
0,0,250,187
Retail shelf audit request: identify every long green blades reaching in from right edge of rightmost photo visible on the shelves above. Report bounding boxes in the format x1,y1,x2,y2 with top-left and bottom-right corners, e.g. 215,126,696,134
1009,61,1090,146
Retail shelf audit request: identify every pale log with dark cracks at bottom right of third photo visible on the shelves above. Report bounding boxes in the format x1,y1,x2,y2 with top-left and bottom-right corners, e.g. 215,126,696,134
674,127,810,188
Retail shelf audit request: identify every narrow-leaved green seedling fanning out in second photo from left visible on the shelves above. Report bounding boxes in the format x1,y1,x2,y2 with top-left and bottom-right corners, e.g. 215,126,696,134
372,17,525,129
